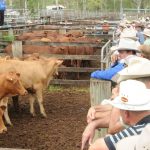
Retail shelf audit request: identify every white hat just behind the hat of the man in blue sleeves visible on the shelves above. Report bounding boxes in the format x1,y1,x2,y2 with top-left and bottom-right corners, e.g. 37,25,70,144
120,28,138,41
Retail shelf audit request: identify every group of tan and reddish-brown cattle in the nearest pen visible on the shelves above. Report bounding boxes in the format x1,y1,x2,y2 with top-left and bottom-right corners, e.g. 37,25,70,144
0,57,63,133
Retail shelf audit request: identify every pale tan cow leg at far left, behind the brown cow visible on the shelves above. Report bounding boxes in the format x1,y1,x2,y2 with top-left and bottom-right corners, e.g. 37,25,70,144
2,97,13,126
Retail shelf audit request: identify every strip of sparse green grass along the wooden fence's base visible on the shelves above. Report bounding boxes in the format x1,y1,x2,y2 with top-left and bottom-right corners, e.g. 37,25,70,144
48,85,89,92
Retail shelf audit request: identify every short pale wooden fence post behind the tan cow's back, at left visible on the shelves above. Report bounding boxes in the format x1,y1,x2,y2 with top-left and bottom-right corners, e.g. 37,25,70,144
12,41,23,58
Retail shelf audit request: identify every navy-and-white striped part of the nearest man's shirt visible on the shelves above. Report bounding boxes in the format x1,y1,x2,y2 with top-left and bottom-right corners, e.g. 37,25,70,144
104,115,150,150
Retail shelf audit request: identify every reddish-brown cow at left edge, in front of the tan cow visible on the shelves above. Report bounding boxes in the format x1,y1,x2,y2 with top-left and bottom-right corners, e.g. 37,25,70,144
0,72,27,133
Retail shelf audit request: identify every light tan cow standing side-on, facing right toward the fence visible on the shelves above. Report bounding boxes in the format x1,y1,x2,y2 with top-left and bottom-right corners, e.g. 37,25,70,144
0,58,63,124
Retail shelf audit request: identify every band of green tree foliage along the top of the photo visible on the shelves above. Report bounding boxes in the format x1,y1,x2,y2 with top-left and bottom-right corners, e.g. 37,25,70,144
6,0,150,11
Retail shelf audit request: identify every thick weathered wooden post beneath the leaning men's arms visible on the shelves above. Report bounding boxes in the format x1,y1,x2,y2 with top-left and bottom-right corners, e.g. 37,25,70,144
90,79,111,141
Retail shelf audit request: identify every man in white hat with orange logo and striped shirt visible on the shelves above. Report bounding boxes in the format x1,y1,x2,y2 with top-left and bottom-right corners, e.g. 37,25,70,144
89,80,150,150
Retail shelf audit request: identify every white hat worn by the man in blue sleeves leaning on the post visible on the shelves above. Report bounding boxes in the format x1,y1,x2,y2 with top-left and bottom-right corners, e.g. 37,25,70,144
117,38,140,52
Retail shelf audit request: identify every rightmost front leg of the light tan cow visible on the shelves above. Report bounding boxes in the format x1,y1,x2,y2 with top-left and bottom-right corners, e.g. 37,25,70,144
36,89,47,118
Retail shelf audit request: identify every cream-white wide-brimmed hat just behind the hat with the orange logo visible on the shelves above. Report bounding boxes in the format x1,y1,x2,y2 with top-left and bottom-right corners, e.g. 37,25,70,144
112,57,150,83
